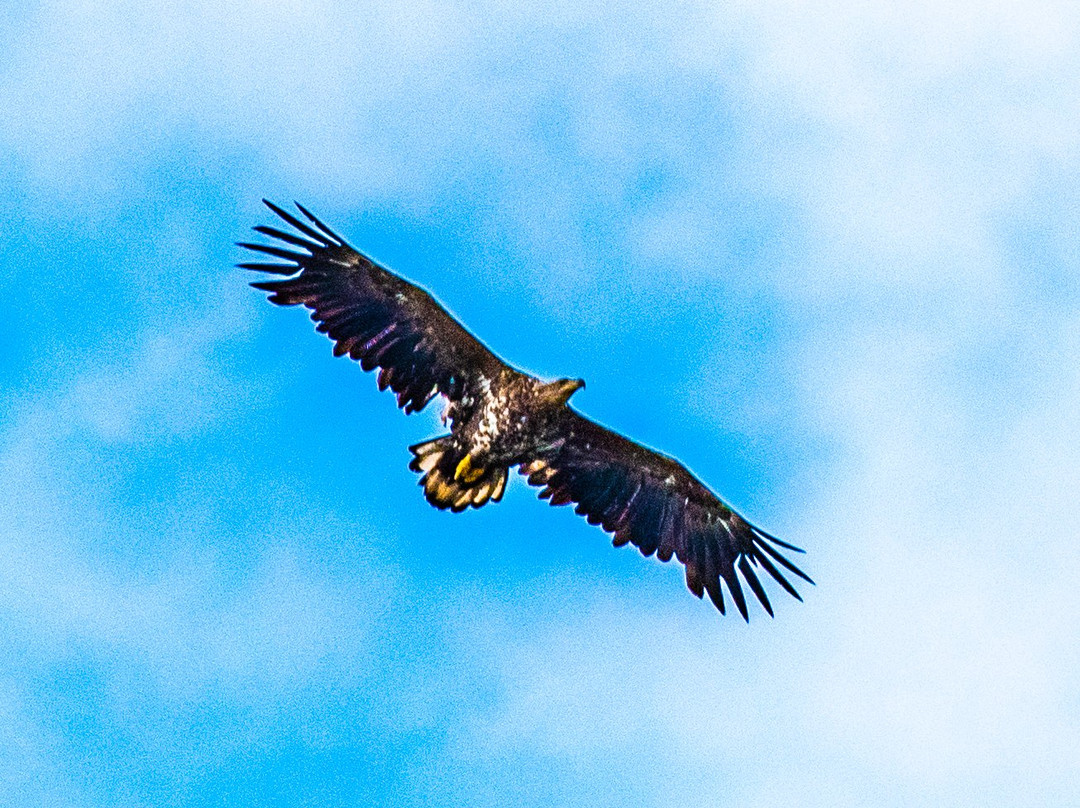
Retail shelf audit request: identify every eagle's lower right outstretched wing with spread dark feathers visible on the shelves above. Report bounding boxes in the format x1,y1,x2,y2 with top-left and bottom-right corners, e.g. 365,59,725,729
521,409,813,621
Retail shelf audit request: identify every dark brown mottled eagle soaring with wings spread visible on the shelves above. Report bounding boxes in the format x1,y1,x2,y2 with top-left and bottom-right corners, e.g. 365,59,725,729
238,200,813,622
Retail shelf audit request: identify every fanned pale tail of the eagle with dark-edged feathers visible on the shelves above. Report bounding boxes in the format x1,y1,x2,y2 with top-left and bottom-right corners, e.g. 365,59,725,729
408,435,509,513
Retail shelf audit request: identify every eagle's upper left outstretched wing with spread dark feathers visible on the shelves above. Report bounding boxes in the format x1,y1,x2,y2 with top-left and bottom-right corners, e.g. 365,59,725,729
238,200,503,413
